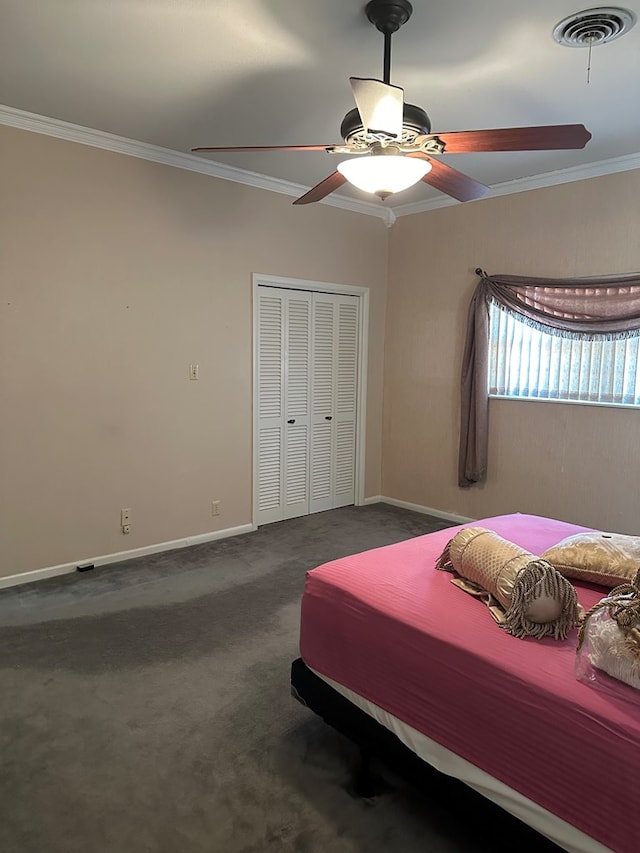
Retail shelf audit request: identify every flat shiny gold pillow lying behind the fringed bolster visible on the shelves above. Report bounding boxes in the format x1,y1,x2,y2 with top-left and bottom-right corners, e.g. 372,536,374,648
541,531,640,588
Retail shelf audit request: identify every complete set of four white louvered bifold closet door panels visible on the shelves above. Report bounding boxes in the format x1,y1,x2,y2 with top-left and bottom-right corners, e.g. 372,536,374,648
255,287,360,525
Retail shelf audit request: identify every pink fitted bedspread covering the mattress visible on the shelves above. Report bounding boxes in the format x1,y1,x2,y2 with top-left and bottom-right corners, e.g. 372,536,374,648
300,514,640,853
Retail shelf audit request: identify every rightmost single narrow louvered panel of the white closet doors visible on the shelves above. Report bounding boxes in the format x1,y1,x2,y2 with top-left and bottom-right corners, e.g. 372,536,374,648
333,297,359,507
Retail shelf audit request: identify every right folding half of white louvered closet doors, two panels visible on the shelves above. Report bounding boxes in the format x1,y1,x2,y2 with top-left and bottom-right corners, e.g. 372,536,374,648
309,293,359,512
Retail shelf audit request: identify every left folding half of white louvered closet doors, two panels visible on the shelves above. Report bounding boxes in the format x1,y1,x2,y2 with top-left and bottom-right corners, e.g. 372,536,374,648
255,288,311,524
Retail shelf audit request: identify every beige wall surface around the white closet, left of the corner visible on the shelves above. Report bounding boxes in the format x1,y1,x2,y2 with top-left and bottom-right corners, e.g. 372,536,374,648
0,127,387,576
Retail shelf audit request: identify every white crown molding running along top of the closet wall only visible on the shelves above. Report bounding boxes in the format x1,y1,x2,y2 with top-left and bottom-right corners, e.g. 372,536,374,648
0,104,395,227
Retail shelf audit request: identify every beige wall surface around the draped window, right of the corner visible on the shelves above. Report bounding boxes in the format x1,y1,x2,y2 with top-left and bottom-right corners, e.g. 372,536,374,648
382,171,640,533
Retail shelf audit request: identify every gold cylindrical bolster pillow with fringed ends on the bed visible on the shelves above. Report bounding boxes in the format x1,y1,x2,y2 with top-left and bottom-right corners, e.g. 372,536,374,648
436,527,580,640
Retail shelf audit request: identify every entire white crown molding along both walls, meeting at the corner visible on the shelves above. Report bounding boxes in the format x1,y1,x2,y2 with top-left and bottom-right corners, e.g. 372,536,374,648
0,104,640,228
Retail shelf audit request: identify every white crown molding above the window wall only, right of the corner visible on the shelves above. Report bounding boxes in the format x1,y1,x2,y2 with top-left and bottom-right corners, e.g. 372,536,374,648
393,154,640,218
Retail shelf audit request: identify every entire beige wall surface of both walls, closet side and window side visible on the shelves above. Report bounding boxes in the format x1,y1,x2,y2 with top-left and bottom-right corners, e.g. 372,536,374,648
0,118,640,576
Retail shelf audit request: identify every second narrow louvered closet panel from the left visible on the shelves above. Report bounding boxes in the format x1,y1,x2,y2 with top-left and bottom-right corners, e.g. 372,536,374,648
283,291,311,518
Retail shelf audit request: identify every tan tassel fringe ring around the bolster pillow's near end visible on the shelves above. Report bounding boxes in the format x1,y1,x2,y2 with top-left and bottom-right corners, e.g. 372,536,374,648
503,560,580,640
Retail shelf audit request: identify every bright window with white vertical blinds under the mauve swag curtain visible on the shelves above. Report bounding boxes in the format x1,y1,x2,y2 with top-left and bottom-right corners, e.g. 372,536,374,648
489,303,640,406
